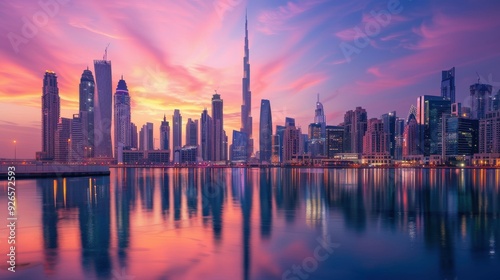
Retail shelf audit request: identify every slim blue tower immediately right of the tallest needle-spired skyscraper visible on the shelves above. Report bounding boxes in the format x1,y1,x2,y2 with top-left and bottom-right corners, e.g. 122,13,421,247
259,99,273,163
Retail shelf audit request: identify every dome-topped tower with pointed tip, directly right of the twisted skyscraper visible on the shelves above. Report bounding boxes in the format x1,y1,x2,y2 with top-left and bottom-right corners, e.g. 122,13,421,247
114,76,132,158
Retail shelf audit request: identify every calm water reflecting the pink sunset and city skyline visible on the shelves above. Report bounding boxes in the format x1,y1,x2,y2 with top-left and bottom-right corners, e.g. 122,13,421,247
0,168,500,280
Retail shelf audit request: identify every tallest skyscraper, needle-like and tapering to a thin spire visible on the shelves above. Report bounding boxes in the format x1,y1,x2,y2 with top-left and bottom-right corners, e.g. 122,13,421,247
239,12,253,157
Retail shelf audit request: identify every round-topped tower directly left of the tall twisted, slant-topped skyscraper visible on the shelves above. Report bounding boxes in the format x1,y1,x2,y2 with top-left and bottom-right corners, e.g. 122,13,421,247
79,67,95,157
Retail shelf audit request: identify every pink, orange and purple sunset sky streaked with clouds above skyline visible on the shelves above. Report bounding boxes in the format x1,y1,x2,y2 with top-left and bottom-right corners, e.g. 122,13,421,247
0,0,500,159
